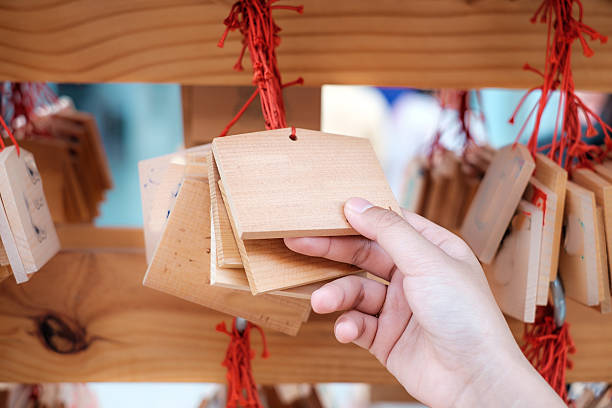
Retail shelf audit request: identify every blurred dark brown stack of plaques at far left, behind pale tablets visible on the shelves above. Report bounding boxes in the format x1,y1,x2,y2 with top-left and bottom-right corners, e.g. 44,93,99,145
6,108,113,223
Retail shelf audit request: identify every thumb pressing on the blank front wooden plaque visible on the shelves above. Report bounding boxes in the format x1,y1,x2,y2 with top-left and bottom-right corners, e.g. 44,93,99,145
344,198,448,275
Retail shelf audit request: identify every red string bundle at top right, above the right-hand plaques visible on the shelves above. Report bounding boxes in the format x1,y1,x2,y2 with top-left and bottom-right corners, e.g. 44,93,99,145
510,0,612,170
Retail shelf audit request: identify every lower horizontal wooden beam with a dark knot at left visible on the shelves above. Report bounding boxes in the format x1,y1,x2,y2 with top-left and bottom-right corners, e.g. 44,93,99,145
0,228,612,384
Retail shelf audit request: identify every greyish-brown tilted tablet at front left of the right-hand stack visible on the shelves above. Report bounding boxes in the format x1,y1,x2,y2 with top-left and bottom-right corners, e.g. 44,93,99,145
460,144,535,263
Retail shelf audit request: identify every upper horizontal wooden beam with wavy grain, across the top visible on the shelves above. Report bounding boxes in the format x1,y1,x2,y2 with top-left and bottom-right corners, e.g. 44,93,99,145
0,0,612,91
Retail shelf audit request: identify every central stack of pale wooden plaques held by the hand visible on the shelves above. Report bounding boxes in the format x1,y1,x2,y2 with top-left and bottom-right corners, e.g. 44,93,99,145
139,129,399,335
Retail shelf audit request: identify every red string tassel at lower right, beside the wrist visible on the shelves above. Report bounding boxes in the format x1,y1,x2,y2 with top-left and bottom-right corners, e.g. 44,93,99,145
521,306,576,403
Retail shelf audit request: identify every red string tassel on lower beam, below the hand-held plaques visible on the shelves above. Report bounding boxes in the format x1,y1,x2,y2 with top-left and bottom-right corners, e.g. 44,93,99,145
216,318,269,408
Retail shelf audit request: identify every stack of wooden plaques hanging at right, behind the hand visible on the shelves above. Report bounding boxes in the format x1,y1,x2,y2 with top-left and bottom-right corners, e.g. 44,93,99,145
405,145,612,322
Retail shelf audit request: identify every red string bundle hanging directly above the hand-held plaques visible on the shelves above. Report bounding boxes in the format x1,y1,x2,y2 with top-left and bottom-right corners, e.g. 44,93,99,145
217,0,304,136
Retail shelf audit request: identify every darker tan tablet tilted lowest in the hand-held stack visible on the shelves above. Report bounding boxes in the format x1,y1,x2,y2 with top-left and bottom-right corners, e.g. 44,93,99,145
143,159,310,335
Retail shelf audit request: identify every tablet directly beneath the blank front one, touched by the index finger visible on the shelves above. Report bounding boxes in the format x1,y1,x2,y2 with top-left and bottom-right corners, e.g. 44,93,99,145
219,180,359,295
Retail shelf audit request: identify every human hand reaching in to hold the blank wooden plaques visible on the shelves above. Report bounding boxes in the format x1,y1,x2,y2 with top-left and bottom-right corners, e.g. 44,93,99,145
285,198,563,407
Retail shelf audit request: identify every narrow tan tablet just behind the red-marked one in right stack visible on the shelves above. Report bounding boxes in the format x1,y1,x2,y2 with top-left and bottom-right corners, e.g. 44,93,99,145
533,153,567,282
